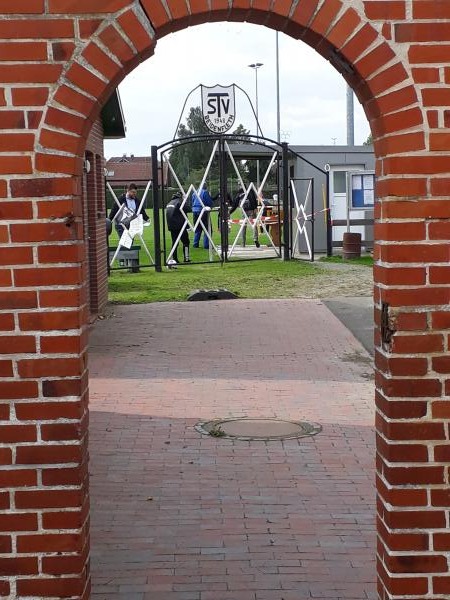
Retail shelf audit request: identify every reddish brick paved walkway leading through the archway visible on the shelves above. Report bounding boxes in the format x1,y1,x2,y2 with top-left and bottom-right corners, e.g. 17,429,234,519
90,300,376,600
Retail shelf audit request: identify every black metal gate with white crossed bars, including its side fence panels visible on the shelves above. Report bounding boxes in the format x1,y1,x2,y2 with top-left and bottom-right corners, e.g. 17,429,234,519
107,135,331,271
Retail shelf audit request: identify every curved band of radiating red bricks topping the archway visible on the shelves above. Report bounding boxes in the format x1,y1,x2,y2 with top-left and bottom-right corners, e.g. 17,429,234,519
38,0,423,164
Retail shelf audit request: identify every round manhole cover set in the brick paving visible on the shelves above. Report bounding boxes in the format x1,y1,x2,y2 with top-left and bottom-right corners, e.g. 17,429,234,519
196,418,322,440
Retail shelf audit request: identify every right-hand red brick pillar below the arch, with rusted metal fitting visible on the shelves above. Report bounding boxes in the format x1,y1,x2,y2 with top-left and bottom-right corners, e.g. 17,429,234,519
375,195,450,599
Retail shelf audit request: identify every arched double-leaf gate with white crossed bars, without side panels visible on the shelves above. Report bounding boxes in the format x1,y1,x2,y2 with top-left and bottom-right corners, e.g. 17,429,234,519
152,135,291,270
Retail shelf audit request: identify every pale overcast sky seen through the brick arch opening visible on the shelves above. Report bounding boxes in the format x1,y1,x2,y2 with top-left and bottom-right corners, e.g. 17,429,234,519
105,22,370,158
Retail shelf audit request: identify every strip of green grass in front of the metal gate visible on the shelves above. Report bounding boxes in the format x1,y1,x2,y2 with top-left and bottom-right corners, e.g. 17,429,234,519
109,259,320,304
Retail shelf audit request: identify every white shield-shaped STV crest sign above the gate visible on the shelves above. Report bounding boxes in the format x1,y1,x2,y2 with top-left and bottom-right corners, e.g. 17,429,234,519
201,85,236,133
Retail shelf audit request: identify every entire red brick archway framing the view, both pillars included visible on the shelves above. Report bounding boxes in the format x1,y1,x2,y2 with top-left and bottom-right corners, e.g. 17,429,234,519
0,0,450,600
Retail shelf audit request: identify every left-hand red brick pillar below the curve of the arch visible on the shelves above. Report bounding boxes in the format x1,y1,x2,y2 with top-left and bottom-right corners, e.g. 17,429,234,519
0,177,89,598
